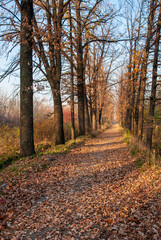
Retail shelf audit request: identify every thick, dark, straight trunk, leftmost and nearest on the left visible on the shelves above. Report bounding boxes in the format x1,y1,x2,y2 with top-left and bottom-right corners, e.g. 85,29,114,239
20,0,35,156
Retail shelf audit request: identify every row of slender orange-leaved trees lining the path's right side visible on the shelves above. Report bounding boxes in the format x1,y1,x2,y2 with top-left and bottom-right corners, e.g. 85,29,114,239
119,0,161,148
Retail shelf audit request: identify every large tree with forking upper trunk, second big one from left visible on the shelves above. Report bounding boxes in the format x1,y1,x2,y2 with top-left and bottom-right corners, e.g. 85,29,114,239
31,0,70,145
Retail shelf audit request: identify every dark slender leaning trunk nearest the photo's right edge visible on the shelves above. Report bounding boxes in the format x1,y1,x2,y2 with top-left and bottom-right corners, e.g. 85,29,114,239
146,3,161,148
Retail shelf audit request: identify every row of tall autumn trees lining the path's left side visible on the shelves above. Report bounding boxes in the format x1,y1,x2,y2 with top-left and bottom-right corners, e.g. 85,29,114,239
0,0,115,156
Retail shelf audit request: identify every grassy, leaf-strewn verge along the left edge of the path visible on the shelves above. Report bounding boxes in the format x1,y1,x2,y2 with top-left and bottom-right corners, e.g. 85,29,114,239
0,124,110,182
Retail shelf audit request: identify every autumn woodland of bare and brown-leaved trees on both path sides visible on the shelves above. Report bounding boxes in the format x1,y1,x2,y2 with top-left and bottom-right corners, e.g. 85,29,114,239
0,1,161,156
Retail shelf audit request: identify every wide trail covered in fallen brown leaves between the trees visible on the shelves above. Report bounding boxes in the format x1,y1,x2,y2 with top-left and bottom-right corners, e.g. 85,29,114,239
1,125,161,240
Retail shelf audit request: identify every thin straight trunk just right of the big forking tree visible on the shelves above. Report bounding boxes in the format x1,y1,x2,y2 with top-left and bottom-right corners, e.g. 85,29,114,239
69,3,75,140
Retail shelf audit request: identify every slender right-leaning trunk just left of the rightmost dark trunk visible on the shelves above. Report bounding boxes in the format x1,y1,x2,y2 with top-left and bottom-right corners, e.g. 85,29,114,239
138,0,157,139
